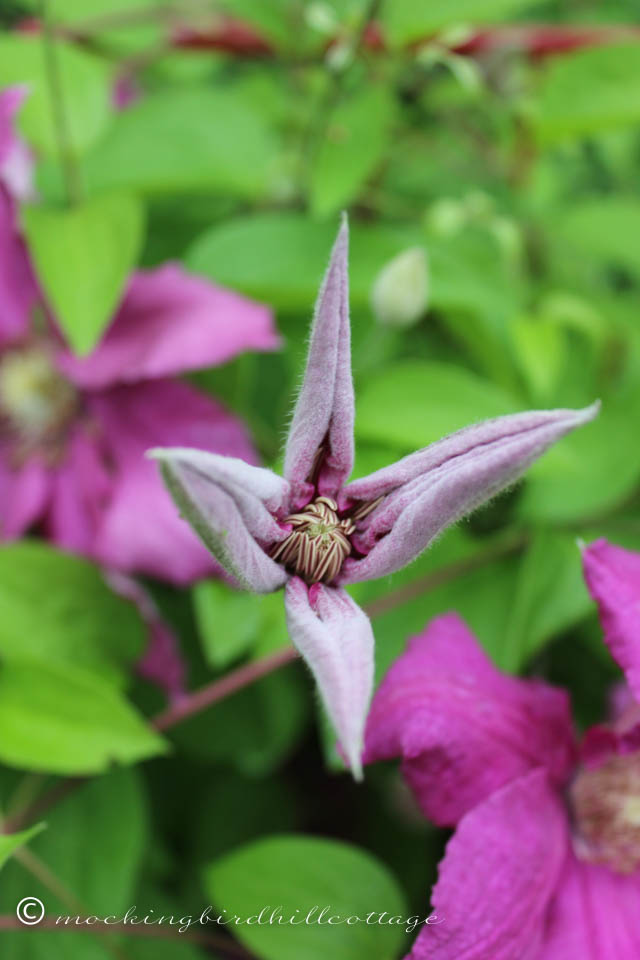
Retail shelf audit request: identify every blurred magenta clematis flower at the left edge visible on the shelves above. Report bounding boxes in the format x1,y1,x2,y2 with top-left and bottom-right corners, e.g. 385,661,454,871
0,89,278,583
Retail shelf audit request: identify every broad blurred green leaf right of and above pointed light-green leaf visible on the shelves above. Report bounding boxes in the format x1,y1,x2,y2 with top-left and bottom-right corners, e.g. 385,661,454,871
85,87,278,198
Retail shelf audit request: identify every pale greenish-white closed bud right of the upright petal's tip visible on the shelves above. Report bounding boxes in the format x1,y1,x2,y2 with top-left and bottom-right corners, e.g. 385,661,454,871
371,247,429,327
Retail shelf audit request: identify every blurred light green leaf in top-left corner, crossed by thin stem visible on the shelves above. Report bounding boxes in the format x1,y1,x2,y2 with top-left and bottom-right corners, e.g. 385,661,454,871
0,33,112,157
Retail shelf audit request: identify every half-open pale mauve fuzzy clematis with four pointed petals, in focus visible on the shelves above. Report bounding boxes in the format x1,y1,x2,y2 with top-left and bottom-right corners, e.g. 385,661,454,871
151,219,598,777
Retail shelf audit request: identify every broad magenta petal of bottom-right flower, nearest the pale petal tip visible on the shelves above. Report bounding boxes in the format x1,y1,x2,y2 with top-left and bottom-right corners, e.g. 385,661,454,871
363,614,575,825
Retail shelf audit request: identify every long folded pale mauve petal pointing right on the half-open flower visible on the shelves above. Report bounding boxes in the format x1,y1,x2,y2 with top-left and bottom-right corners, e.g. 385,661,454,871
339,403,599,584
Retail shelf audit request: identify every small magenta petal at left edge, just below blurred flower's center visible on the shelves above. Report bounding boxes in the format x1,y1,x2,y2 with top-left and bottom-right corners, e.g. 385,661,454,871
0,446,51,540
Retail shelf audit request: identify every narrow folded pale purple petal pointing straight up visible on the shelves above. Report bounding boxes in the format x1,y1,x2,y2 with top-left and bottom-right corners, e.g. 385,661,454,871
284,218,354,508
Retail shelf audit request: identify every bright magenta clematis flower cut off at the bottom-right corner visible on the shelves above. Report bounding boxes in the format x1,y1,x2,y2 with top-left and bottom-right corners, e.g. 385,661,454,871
364,608,640,960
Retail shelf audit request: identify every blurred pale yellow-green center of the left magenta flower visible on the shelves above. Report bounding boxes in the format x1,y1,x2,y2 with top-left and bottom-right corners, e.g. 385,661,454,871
0,347,77,448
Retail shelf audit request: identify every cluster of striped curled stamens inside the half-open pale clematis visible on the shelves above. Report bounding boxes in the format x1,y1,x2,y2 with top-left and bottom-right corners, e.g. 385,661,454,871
271,497,355,584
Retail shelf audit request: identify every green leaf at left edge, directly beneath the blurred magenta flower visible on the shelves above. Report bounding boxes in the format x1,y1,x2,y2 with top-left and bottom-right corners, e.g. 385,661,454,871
0,541,145,686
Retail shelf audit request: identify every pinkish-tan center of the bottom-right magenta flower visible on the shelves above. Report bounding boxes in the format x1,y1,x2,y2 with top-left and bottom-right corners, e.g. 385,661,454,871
571,753,640,873
